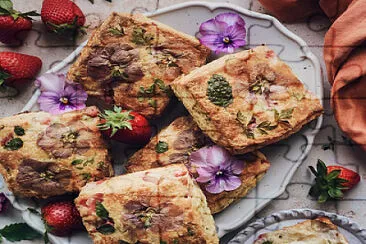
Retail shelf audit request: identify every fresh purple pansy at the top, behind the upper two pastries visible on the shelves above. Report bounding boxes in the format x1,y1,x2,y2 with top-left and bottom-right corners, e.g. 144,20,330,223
199,13,246,53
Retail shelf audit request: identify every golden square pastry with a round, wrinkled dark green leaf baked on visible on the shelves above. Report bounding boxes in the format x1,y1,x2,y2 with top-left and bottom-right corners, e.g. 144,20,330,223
171,46,323,154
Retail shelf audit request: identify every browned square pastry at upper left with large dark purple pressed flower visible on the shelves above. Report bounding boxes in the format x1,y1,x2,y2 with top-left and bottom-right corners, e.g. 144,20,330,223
68,13,210,118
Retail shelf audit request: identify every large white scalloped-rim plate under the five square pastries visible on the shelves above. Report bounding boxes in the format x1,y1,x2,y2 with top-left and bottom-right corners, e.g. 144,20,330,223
2,2,323,243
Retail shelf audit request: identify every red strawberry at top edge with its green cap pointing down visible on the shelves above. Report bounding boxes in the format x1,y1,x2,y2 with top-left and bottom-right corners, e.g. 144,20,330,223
41,0,85,36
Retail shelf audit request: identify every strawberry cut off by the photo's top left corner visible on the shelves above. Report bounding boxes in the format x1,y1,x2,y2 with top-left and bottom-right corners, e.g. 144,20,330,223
0,0,39,44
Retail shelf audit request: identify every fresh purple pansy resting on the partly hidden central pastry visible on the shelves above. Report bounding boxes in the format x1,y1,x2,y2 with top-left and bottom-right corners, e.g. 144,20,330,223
190,145,244,194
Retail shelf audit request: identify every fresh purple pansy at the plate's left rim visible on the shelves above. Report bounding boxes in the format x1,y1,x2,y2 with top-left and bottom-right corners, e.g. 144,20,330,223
36,73,88,114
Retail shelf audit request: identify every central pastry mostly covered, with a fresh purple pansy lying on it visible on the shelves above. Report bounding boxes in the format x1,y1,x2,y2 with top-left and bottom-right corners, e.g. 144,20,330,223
126,116,270,214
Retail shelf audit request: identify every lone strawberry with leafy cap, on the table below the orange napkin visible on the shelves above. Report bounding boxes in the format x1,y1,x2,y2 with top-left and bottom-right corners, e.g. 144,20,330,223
309,159,360,203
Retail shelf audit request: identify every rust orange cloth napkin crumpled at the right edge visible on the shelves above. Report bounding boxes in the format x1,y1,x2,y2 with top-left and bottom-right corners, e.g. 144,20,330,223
259,0,366,150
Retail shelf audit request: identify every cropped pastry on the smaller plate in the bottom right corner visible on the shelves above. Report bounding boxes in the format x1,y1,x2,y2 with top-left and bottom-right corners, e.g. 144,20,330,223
254,217,348,244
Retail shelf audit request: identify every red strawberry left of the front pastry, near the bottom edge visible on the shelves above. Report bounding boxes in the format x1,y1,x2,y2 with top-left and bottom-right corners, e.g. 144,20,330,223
42,201,82,236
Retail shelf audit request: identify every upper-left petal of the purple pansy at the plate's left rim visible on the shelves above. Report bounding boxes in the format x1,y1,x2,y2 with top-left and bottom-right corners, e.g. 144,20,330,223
36,73,66,92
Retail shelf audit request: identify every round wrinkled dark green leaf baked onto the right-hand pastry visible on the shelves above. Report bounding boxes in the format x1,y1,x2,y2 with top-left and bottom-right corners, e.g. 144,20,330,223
207,74,233,107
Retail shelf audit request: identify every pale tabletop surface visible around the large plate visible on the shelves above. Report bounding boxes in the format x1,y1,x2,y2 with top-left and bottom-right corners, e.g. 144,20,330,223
0,0,366,243
